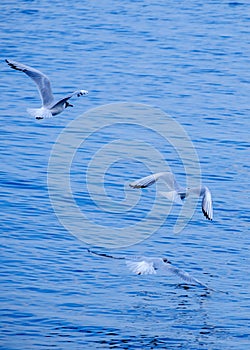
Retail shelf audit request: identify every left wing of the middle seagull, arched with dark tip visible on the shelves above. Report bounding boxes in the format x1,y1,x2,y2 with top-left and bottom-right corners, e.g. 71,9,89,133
129,172,179,189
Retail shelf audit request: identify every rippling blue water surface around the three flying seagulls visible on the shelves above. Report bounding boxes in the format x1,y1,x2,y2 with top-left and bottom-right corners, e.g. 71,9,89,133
0,0,250,350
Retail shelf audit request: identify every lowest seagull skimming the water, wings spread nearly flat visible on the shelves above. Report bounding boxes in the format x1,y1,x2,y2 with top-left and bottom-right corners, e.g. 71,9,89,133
87,249,214,290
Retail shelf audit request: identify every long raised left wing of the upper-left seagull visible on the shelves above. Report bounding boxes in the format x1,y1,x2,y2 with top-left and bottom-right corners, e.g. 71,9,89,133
6,60,54,107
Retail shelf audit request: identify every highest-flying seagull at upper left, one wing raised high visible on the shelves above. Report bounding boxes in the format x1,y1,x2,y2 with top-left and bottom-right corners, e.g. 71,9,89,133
5,60,88,119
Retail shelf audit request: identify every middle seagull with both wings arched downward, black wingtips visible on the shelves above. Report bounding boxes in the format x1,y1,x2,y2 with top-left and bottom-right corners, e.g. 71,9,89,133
129,172,213,220
